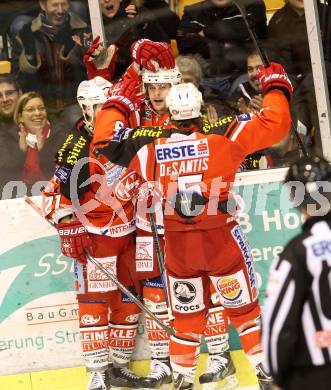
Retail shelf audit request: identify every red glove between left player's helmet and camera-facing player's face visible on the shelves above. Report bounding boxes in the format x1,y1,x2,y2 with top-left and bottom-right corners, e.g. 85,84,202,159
103,78,144,127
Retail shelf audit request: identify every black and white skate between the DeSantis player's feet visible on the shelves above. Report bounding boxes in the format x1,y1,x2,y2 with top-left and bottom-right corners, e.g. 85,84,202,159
199,352,238,389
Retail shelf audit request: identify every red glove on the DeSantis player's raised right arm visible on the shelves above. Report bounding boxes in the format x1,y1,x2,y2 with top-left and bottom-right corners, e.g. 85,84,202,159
258,62,293,102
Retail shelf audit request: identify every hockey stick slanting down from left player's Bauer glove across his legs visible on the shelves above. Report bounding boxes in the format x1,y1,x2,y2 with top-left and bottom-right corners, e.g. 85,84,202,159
24,196,175,335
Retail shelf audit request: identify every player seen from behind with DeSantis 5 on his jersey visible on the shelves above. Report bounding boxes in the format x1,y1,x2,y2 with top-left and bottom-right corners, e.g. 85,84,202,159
95,63,292,389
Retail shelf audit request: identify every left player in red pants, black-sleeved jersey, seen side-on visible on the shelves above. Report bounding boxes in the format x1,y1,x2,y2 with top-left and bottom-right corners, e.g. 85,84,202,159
44,77,149,390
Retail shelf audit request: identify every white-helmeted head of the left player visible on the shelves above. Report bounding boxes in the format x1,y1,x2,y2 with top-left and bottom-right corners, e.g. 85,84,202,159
77,76,113,130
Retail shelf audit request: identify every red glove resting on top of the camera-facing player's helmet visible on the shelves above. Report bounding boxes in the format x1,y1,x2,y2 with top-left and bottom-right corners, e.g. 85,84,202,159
131,39,175,72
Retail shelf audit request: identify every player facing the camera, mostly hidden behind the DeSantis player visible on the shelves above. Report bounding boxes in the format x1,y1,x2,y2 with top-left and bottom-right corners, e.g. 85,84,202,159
85,39,240,388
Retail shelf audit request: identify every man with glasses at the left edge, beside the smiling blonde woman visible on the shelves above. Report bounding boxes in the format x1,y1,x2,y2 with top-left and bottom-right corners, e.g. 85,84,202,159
0,75,24,199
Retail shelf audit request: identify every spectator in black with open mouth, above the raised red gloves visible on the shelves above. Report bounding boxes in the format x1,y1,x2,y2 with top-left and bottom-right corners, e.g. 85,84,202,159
100,0,179,79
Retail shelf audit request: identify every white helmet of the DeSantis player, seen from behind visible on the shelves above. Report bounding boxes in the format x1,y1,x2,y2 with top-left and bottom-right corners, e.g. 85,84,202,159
166,83,203,121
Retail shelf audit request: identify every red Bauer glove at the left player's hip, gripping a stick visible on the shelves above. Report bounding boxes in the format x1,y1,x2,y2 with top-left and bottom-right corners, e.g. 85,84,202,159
56,220,92,264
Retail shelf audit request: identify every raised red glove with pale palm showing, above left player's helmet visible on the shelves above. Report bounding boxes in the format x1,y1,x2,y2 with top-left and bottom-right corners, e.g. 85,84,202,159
83,35,117,81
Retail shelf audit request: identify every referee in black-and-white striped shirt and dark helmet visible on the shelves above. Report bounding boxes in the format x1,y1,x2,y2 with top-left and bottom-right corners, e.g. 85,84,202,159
262,156,331,390
